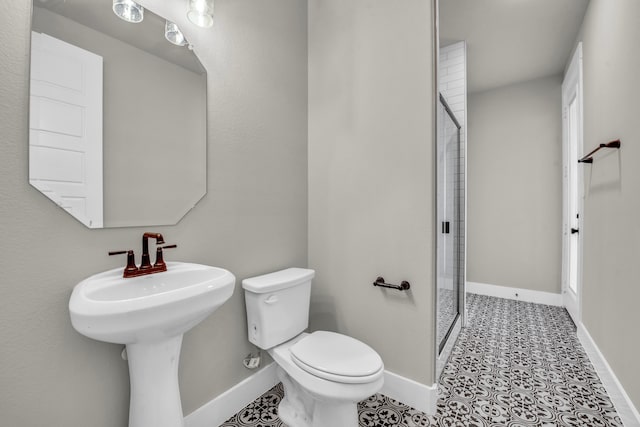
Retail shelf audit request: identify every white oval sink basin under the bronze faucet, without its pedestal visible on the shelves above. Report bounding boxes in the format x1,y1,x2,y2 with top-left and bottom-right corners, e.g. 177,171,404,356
69,262,235,344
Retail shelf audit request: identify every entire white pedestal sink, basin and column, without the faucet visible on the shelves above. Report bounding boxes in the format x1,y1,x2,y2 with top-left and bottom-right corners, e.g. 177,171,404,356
69,262,235,427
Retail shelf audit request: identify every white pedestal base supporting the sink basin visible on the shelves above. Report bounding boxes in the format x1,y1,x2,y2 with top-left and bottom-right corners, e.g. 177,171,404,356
127,334,184,427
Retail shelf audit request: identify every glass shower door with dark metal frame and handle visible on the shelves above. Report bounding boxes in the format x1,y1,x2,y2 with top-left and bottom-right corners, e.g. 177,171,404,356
436,95,465,375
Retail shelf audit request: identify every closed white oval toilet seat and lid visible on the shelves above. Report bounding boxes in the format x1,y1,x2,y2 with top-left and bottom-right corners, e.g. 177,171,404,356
289,331,384,384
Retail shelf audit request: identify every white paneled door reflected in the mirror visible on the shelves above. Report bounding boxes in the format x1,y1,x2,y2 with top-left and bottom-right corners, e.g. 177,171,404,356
29,32,103,228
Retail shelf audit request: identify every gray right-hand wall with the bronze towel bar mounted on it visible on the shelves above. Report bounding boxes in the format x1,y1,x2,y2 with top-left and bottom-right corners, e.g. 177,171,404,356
581,0,640,408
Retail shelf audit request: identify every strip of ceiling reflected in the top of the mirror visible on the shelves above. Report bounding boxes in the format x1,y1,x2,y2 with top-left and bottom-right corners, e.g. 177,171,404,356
33,0,204,74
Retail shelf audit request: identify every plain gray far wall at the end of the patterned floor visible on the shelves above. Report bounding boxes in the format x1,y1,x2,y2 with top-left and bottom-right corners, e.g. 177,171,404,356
467,76,562,293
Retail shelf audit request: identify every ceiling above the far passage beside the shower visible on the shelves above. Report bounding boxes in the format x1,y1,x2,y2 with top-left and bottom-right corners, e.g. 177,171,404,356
439,0,589,93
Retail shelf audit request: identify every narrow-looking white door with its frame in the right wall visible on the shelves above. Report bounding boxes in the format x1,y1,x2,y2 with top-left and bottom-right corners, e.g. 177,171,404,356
562,44,584,324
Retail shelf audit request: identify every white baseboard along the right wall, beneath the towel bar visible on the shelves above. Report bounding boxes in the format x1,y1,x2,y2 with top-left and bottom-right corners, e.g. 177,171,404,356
577,323,640,427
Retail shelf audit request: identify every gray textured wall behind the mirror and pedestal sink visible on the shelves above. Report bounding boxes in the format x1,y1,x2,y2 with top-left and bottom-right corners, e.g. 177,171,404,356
0,0,307,427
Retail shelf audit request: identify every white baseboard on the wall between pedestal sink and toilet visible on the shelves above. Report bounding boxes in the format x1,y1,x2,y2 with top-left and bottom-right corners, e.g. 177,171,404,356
184,362,279,427
